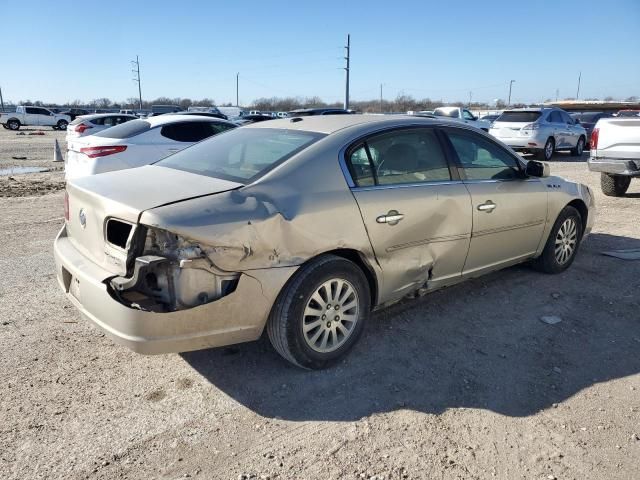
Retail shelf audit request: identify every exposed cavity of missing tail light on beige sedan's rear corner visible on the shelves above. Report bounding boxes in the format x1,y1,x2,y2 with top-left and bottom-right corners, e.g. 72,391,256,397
108,226,240,312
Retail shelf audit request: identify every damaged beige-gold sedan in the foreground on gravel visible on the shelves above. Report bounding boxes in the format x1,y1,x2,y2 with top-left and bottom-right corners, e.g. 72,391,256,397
54,115,594,368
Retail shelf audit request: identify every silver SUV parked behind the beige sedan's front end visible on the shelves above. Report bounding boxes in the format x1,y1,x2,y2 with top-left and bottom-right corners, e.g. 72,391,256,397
489,108,587,161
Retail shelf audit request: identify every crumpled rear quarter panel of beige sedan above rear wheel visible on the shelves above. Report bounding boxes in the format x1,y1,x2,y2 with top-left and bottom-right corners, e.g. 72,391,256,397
140,136,375,278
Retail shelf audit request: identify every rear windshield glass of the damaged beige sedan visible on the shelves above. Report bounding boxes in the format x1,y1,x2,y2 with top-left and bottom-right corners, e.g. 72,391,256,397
156,127,325,184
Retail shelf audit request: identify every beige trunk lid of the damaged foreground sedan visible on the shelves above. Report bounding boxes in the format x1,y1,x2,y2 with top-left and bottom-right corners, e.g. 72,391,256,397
66,165,242,275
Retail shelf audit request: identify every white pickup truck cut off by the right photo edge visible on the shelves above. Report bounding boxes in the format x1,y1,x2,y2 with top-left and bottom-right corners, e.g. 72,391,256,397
588,118,640,197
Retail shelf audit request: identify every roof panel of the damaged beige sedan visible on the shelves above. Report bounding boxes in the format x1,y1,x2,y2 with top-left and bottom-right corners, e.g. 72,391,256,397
242,114,460,134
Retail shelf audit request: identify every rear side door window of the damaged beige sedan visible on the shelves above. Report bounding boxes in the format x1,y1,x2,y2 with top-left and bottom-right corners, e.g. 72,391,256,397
348,128,451,186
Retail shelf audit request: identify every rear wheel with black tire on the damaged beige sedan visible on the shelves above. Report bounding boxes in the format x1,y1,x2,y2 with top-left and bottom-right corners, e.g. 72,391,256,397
267,255,371,369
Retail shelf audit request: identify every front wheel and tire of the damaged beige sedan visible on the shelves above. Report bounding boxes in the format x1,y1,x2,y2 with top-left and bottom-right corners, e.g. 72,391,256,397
532,206,582,273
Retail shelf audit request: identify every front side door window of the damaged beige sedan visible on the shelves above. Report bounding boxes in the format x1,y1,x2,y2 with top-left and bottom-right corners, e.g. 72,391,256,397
447,131,522,180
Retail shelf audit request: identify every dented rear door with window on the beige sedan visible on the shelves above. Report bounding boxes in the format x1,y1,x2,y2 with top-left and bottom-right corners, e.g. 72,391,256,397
347,128,472,299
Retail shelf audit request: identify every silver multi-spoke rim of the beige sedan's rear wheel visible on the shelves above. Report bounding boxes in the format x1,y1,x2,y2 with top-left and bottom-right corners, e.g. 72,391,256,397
302,278,359,353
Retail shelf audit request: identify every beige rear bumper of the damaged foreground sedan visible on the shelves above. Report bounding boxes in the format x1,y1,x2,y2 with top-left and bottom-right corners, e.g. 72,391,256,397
54,227,297,354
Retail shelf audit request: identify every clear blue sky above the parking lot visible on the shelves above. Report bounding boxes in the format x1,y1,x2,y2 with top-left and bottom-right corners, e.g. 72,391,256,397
0,0,640,105
